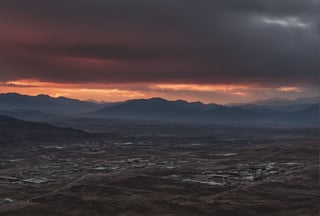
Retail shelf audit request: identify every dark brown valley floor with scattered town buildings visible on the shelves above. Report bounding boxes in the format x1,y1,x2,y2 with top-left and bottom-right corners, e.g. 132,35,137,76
0,125,320,216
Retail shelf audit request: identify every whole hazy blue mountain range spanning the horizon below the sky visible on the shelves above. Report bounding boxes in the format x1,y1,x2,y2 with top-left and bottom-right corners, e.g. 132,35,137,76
0,93,320,123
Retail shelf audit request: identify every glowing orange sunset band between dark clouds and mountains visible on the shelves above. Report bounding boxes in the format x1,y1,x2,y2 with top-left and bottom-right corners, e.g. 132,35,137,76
0,79,312,104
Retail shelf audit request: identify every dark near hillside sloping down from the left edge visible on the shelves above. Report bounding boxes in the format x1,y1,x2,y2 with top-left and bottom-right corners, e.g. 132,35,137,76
0,116,90,144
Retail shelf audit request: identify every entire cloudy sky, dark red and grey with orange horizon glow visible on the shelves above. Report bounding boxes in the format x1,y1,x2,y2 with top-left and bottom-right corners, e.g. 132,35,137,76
0,0,320,103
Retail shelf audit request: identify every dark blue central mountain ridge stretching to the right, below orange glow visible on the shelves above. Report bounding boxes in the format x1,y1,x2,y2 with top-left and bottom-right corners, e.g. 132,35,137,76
91,98,316,123
